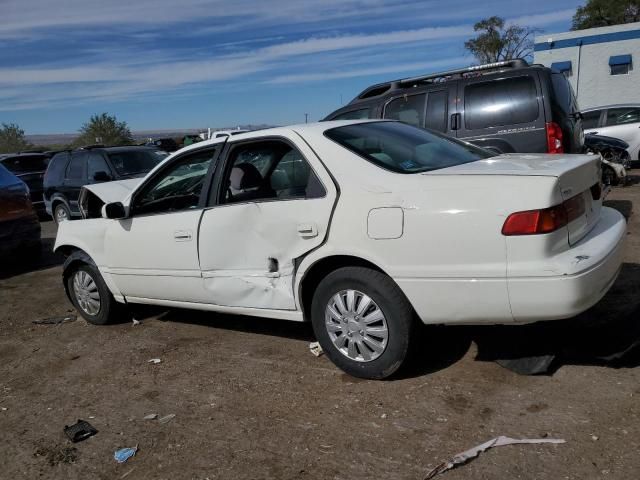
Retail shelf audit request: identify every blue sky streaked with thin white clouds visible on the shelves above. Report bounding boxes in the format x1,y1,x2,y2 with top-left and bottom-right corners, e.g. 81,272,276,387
0,0,584,134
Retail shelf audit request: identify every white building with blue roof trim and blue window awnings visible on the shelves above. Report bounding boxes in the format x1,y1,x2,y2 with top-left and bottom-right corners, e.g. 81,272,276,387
534,22,640,108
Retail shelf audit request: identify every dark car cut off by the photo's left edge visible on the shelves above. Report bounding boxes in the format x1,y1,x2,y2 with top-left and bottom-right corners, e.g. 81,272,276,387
0,161,41,258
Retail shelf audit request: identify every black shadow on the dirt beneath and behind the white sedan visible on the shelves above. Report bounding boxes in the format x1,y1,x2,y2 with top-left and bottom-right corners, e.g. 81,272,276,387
134,263,640,379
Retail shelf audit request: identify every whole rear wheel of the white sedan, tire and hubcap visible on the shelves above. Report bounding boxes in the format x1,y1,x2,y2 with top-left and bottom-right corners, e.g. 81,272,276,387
311,267,414,379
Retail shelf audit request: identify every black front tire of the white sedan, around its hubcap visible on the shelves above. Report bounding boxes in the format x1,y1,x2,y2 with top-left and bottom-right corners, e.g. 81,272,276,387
65,263,128,325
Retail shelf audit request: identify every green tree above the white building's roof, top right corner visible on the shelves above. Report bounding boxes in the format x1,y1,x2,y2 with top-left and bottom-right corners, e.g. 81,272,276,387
571,0,640,30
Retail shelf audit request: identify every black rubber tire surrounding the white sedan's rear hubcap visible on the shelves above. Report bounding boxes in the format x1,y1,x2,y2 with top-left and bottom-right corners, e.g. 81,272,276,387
311,267,415,380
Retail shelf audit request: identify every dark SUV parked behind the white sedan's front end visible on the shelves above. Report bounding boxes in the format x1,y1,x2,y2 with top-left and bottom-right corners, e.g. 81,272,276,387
44,146,167,223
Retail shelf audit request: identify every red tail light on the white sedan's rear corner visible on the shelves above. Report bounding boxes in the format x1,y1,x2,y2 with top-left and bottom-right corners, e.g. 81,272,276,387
502,194,586,236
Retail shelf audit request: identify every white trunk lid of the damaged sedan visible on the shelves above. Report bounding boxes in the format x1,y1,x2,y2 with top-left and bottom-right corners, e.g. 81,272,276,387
424,154,602,245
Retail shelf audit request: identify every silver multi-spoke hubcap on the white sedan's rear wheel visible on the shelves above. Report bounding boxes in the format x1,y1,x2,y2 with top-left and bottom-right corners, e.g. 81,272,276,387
325,290,389,362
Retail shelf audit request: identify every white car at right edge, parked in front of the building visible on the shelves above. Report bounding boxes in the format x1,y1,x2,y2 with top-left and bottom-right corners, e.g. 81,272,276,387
582,103,640,161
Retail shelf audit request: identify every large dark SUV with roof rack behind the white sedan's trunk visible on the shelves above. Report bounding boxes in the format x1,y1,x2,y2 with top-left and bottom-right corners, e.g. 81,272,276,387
325,59,584,153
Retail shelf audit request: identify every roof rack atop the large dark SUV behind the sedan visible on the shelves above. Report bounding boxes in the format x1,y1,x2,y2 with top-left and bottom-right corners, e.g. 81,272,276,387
352,58,529,103
